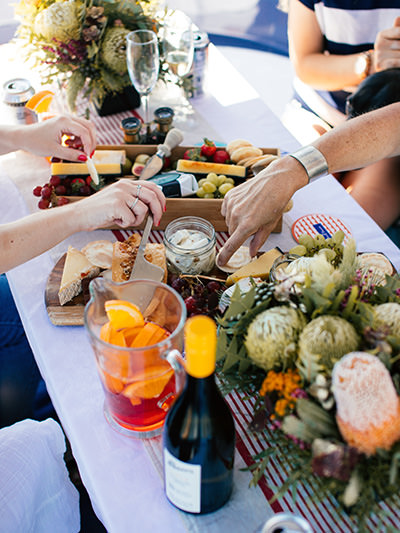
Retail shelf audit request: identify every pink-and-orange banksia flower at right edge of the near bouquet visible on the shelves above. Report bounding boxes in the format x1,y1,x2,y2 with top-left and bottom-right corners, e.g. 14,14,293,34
332,352,400,455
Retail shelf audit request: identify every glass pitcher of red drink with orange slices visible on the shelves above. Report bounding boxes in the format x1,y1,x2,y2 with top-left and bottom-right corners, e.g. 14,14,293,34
85,278,186,438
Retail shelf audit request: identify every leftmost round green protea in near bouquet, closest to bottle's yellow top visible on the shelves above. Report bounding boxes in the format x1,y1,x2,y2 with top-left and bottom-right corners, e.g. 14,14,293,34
245,306,306,371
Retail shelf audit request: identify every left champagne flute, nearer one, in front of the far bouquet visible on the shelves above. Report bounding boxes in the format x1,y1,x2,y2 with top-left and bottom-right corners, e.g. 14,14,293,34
126,30,160,137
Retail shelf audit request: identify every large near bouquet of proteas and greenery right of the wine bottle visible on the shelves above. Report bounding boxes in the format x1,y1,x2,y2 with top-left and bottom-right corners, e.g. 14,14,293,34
218,232,400,531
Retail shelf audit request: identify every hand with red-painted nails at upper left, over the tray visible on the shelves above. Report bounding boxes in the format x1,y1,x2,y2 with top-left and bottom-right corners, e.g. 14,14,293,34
16,115,96,161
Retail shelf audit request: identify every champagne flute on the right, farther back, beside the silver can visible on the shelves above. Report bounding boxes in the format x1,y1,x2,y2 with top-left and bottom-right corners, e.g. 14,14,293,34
162,10,194,121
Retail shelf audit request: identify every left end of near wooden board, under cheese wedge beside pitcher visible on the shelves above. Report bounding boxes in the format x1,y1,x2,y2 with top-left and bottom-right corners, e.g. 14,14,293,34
44,254,85,326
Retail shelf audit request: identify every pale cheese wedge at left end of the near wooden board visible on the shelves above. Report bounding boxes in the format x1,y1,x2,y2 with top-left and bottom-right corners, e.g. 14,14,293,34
58,246,100,305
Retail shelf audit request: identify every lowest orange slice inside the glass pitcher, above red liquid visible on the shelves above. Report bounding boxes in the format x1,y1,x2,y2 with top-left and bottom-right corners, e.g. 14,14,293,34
122,365,174,401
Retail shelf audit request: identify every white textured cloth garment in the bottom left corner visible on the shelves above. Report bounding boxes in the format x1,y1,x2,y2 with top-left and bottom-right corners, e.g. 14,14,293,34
0,418,80,533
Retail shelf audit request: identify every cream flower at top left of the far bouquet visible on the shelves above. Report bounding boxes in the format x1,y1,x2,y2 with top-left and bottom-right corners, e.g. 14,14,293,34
35,1,80,43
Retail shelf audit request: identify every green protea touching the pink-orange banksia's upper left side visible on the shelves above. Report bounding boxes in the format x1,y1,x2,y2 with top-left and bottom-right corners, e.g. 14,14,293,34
298,315,359,382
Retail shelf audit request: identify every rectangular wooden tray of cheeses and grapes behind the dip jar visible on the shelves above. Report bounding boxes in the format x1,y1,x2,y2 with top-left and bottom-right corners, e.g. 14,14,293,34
56,144,282,233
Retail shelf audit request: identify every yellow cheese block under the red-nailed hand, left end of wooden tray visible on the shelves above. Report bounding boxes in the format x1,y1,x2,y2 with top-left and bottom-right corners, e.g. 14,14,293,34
51,150,126,176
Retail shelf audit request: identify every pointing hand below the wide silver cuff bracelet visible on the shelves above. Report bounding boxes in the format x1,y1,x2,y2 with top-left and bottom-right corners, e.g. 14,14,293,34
218,157,306,266
